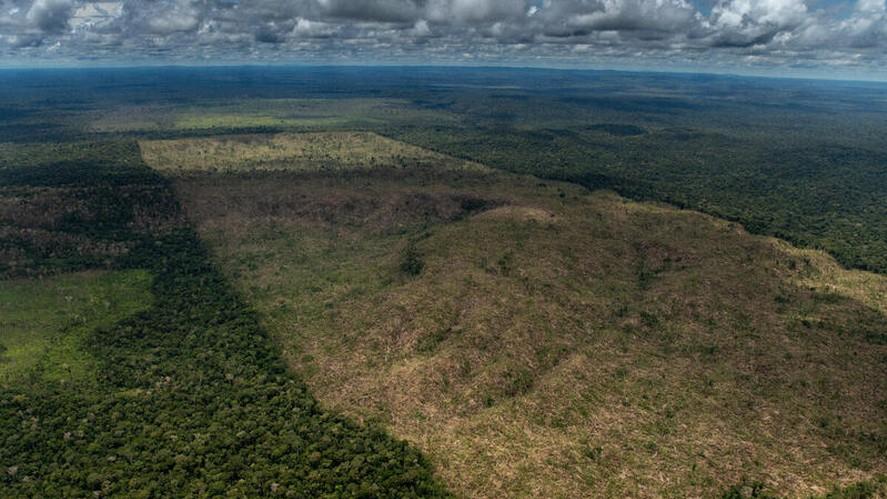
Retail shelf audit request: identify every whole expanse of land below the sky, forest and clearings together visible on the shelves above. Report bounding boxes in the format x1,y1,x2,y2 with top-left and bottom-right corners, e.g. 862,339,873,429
0,67,887,499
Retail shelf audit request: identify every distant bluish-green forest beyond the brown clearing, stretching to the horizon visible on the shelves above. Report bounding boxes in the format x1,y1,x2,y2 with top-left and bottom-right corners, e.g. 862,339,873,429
0,67,887,273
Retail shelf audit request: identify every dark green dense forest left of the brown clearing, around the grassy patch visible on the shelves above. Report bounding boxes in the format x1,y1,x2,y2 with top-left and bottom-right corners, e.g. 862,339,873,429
0,143,446,497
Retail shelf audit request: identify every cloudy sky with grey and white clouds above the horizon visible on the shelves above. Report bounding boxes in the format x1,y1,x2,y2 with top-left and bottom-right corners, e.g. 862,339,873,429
0,0,887,79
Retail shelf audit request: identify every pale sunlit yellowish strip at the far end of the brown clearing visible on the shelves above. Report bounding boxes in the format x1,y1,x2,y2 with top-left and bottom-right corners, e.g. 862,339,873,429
139,132,483,174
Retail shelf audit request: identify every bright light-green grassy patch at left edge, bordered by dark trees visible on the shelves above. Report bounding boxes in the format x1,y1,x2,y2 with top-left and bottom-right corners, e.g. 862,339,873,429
0,270,151,386
